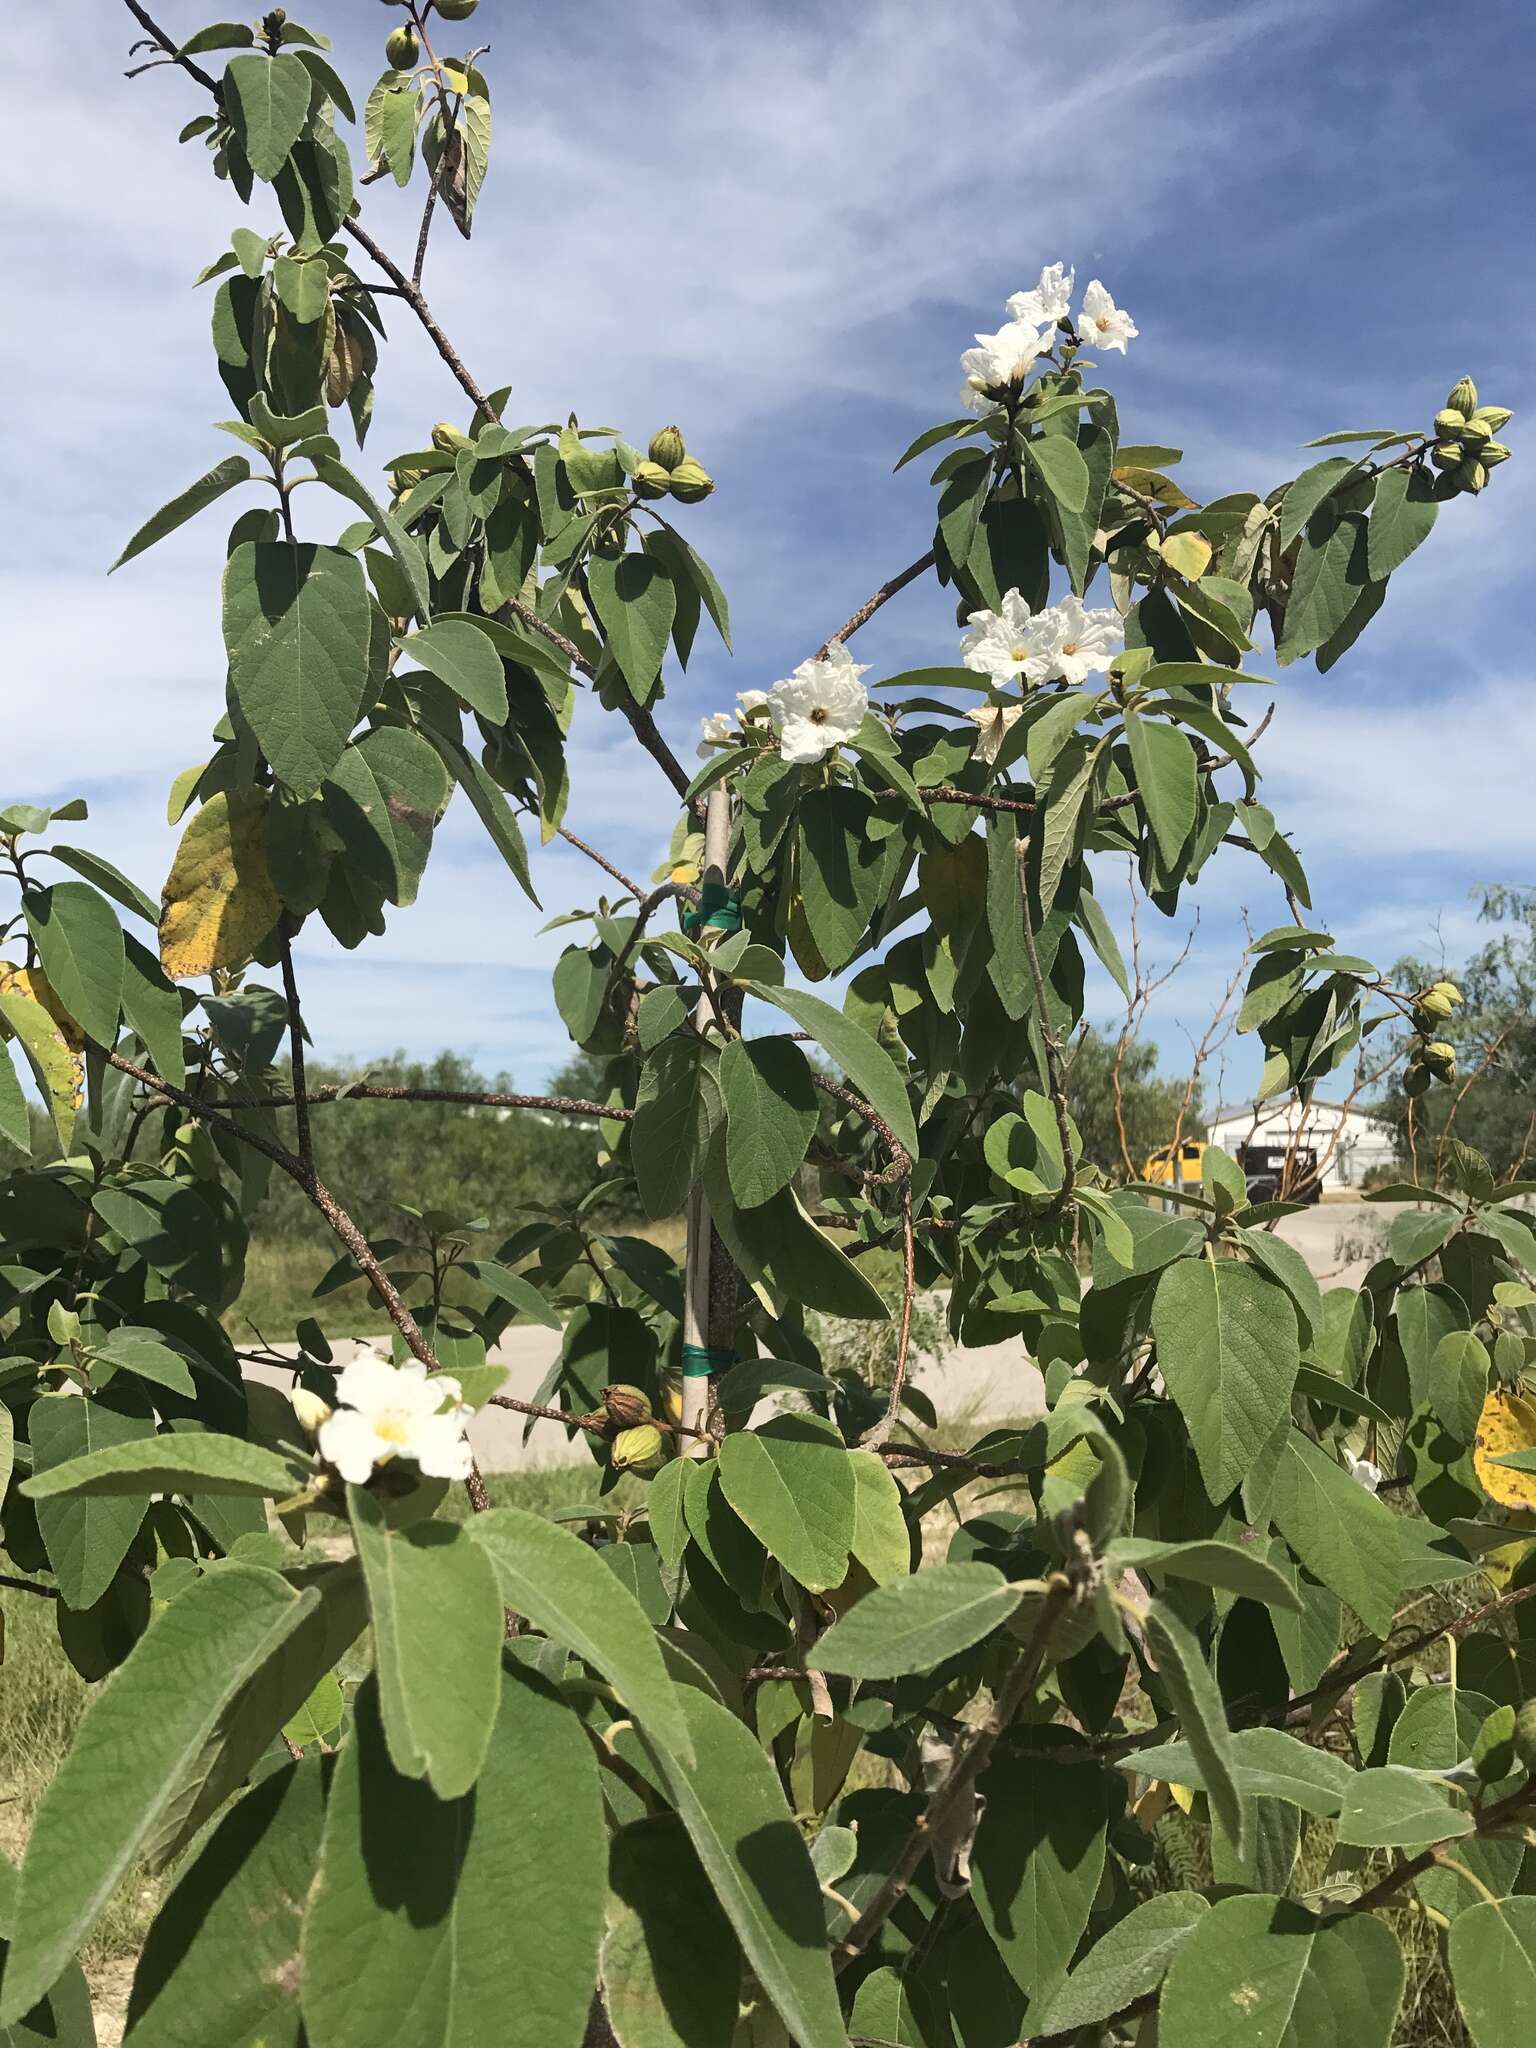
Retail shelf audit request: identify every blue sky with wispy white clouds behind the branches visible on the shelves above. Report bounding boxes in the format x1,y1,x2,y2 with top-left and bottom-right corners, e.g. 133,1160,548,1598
0,0,1536,1100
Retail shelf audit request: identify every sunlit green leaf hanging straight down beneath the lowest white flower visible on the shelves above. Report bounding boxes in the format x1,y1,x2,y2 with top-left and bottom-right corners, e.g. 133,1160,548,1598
346,1487,502,1800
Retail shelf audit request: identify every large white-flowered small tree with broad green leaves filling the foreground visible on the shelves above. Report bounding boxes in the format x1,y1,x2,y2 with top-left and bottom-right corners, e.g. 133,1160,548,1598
0,0,1536,2048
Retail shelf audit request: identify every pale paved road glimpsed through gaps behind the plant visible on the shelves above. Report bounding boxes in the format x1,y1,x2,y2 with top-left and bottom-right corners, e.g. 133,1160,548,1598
249,1202,1397,1473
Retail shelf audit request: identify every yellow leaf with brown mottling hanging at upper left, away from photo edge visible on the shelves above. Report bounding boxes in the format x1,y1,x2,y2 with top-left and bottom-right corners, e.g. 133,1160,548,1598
160,788,283,981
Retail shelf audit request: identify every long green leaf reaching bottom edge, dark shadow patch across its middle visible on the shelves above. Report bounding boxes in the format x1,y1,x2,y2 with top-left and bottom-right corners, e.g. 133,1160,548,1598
638,1679,848,2048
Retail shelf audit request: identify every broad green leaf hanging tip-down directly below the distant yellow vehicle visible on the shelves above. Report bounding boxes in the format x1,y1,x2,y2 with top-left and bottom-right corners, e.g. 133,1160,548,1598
1151,1257,1300,1501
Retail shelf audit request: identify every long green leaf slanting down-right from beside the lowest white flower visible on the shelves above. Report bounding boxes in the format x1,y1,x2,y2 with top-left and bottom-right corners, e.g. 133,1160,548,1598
467,1499,692,1763
